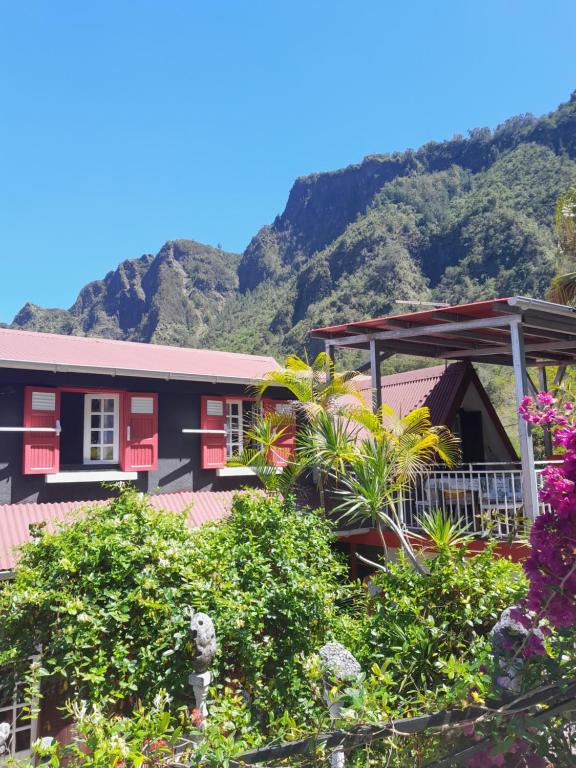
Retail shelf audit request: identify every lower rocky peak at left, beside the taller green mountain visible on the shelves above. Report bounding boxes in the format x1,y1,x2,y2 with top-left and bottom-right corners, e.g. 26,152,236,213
12,240,240,346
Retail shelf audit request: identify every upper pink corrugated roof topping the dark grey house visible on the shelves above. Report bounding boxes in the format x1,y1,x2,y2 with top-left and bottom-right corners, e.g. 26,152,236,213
0,328,279,384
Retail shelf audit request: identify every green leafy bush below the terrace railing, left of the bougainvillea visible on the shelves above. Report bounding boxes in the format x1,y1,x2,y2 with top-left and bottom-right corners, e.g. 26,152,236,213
346,547,526,711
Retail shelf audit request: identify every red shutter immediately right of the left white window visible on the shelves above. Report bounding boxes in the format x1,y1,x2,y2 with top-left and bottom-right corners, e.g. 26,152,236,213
120,392,158,472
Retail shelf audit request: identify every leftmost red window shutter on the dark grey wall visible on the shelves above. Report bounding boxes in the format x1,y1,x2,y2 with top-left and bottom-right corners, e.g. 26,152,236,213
23,387,60,475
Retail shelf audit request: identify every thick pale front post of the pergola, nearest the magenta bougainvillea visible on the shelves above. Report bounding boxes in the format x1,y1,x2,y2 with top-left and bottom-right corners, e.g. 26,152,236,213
510,318,538,522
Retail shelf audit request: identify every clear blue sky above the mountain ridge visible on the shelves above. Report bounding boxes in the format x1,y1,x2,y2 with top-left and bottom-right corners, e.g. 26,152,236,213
0,0,576,321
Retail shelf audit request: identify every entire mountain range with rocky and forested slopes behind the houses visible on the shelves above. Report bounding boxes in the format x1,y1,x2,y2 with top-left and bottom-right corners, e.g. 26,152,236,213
13,92,576,355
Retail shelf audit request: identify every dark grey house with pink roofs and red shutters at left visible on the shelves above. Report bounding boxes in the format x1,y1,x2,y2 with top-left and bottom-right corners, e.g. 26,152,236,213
0,329,290,570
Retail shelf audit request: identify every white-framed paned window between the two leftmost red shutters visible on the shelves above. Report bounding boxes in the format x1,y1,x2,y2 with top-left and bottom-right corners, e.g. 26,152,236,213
84,394,119,464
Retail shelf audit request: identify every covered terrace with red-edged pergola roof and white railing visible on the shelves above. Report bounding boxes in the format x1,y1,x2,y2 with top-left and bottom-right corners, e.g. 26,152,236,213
312,296,576,539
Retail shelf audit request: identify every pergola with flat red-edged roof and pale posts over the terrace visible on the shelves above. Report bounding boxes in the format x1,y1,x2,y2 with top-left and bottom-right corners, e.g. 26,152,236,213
311,296,576,519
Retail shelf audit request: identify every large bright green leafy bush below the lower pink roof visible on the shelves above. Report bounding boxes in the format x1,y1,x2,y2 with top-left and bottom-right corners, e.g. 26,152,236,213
0,490,343,706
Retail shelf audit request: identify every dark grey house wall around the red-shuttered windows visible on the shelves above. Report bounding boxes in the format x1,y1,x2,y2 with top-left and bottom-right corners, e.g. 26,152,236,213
0,369,286,504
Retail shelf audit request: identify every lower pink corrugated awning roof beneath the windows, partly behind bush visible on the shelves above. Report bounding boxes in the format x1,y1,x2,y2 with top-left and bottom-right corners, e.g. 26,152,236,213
0,491,237,570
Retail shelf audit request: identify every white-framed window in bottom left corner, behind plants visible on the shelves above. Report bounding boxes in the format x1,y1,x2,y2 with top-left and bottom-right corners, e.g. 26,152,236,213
0,667,37,764
